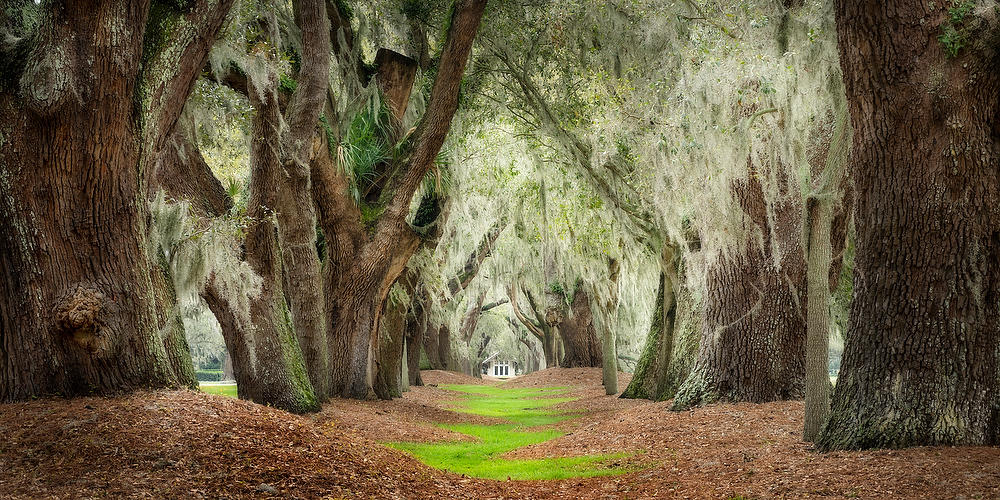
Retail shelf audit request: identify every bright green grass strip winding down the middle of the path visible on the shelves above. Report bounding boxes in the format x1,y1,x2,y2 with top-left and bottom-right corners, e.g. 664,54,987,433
387,385,629,480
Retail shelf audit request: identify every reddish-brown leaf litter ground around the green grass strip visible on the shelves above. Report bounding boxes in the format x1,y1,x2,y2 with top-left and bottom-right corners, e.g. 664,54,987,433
0,369,1000,499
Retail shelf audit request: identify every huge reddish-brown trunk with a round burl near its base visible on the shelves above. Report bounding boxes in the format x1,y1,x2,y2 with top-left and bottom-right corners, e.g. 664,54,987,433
0,1,231,401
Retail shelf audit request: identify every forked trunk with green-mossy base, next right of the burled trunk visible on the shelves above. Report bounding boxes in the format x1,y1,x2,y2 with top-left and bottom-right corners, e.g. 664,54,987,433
230,0,330,411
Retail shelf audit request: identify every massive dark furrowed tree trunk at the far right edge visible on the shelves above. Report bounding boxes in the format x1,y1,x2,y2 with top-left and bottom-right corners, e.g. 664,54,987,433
818,0,1000,450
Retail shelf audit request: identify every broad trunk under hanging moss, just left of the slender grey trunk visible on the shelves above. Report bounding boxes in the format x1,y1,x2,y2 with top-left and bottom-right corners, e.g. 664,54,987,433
673,169,806,409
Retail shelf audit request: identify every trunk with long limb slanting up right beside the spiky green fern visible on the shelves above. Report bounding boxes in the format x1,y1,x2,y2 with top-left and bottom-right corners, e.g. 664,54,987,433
323,0,486,399
